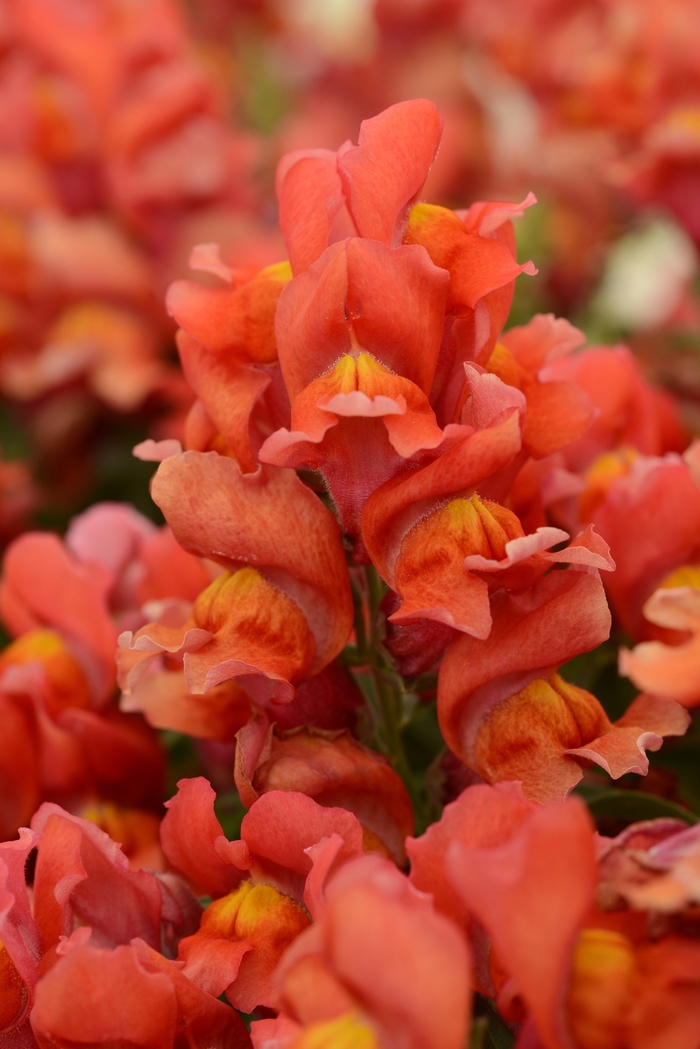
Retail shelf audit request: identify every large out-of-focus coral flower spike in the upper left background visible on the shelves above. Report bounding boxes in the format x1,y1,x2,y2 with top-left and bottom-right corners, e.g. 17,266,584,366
0,0,265,503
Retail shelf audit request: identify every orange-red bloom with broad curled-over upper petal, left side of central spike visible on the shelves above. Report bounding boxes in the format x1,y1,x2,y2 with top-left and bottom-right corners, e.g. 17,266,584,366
118,452,353,703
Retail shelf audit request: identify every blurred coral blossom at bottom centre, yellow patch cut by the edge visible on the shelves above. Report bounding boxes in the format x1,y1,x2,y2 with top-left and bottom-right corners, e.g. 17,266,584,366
252,857,469,1049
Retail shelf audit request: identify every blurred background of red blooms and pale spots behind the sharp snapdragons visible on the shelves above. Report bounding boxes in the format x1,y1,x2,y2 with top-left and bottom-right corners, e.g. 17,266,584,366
0,0,700,539
